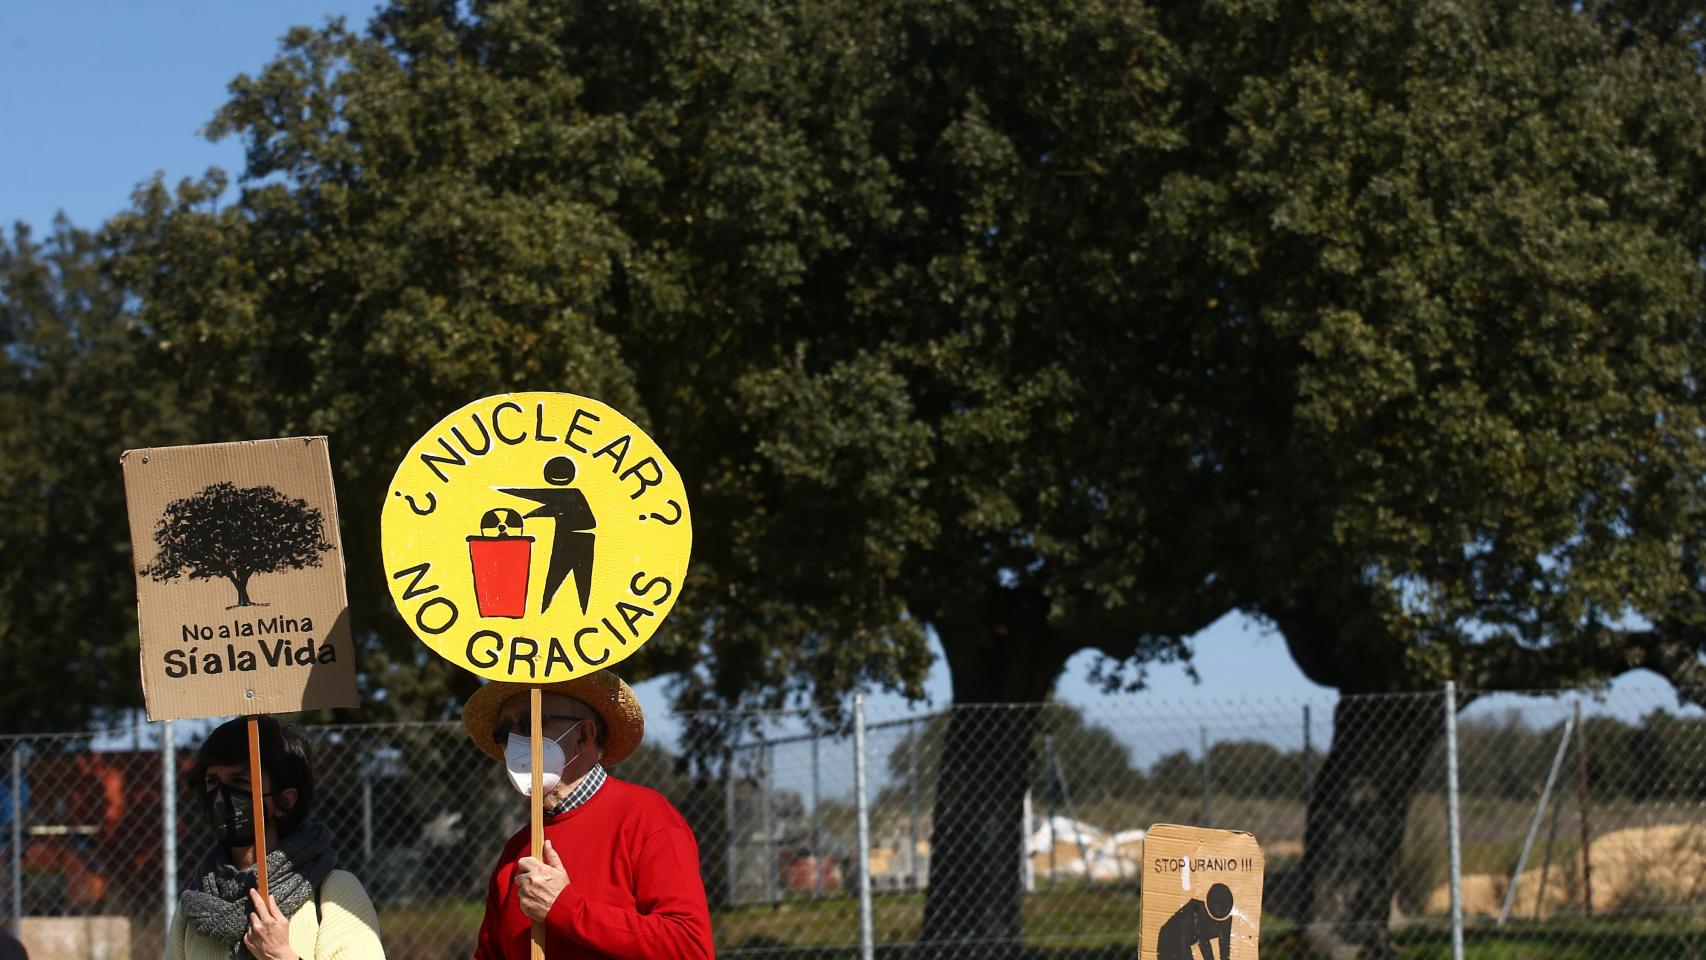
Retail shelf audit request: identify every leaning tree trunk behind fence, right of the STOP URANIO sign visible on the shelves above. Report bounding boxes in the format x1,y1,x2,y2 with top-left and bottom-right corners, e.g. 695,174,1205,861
1302,696,1443,960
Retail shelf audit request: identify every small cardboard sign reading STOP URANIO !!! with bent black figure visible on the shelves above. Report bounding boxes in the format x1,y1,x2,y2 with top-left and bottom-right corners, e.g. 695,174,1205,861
1138,824,1262,960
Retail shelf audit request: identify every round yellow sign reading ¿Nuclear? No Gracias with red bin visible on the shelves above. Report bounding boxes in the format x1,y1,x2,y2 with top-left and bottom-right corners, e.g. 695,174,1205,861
380,394,693,684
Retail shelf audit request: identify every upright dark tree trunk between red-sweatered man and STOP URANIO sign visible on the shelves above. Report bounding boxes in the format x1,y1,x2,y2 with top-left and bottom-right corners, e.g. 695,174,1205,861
920,629,1061,960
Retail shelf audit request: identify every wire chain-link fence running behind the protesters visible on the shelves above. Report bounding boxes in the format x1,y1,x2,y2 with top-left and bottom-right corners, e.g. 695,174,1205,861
0,689,1706,960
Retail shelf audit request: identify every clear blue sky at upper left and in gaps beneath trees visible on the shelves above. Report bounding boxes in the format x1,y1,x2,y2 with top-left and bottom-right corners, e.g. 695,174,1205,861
0,0,1685,750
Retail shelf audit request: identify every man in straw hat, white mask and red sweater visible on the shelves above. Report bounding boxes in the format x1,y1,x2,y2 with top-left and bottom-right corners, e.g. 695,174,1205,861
462,670,713,960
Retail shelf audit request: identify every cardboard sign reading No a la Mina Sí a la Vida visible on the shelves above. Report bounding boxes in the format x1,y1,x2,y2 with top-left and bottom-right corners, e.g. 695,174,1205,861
123,437,358,720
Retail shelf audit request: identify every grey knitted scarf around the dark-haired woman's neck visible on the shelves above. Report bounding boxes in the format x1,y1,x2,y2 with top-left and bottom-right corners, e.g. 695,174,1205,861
179,820,338,960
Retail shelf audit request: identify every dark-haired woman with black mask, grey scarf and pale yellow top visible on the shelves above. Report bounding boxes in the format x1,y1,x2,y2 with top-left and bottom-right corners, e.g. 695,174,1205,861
165,716,384,960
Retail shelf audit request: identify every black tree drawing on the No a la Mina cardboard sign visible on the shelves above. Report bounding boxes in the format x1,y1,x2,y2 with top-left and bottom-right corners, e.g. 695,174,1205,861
142,481,331,607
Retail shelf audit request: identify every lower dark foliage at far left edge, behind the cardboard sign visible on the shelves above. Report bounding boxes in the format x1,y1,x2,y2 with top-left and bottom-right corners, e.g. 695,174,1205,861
0,222,188,733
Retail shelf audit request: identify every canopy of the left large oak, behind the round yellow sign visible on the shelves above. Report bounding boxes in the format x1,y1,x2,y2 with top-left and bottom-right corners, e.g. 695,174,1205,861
103,3,1255,722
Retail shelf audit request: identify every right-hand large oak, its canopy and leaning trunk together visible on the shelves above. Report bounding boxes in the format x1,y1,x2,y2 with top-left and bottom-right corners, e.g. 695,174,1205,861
1160,3,1706,955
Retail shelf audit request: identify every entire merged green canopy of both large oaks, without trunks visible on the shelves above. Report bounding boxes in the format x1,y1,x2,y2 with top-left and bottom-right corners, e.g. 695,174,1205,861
83,3,1699,722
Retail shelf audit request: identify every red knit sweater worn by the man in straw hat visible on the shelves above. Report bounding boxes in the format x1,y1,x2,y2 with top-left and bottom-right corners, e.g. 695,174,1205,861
474,778,711,960
